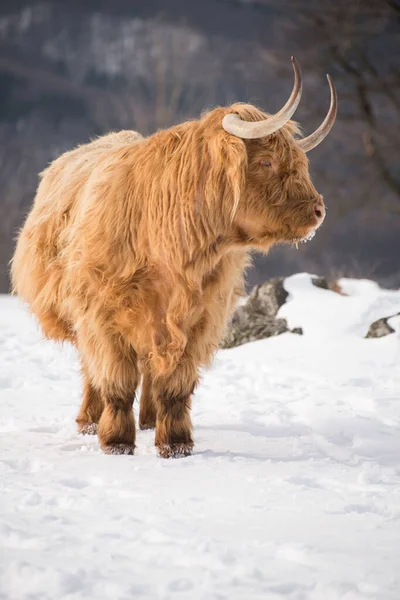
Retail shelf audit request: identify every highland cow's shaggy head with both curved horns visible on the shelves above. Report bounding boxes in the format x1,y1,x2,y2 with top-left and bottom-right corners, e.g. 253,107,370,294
203,57,337,248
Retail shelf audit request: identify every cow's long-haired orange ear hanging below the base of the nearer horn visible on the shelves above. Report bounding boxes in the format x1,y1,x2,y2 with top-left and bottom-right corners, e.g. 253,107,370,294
208,128,247,218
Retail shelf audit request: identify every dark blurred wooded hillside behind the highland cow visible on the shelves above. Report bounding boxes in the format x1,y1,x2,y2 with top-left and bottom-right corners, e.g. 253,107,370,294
0,0,400,292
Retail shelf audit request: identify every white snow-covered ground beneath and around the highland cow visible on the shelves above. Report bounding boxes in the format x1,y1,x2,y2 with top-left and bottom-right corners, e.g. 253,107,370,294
0,275,400,600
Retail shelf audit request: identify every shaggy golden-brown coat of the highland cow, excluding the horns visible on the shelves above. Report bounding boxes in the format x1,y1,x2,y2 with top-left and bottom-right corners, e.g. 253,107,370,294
12,104,321,457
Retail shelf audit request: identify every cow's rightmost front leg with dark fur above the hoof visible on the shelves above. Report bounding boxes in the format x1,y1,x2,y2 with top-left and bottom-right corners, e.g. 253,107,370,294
154,361,197,458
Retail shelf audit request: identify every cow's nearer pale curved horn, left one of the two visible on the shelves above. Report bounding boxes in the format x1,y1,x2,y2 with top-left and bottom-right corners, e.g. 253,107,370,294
222,56,302,140
